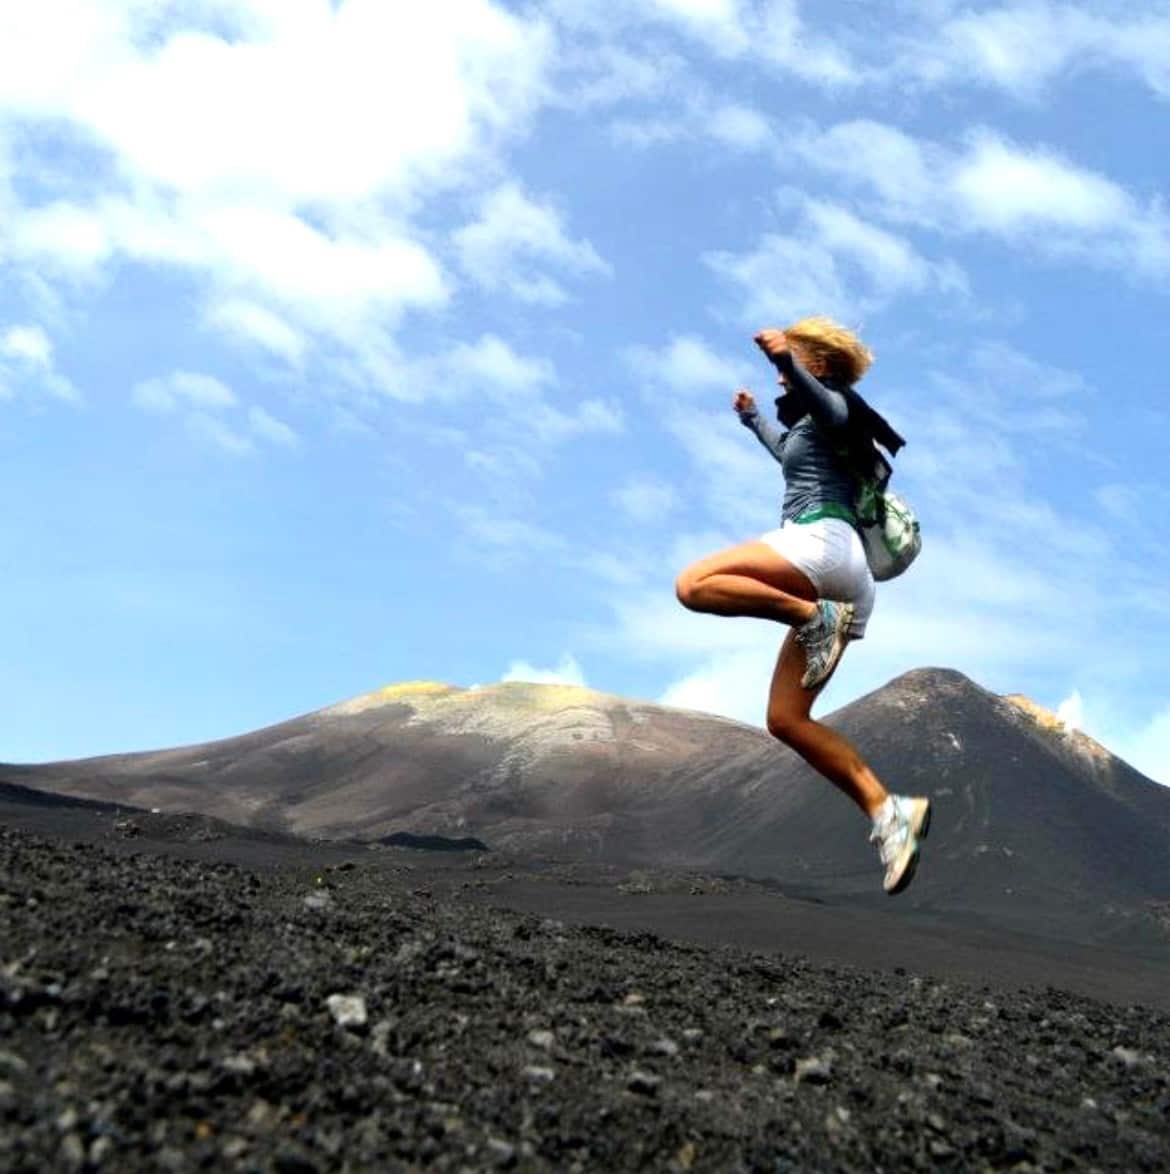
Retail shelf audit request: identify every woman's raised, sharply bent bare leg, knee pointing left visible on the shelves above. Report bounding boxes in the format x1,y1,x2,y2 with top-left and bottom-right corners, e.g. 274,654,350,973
675,542,817,629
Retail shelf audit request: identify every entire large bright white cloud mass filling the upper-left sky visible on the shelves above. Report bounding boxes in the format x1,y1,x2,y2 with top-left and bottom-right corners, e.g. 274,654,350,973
0,0,556,384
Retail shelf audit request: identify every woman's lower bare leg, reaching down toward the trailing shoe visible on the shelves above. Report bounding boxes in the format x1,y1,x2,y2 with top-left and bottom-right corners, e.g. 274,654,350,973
767,632,888,819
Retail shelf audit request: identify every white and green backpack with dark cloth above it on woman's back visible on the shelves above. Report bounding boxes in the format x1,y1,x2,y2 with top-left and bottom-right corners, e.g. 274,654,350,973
838,387,922,582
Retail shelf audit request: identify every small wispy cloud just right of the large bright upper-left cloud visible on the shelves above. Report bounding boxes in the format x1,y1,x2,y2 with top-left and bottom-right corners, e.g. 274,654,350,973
453,183,611,305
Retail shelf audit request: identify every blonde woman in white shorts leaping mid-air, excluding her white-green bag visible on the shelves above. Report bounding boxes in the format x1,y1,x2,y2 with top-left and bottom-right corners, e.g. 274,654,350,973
676,318,931,895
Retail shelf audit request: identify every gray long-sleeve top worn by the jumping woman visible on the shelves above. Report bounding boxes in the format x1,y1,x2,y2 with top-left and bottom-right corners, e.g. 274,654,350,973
739,351,854,521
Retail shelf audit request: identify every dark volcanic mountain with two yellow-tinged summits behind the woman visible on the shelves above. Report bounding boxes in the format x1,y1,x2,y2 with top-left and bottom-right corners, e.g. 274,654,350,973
0,668,1170,942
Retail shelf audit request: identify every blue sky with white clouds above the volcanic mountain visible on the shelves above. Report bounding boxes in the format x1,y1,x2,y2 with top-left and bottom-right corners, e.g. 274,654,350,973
0,0,1170,782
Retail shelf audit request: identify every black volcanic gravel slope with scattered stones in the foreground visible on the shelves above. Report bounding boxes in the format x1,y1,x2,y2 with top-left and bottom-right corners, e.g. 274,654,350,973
0,829,1170,1174
